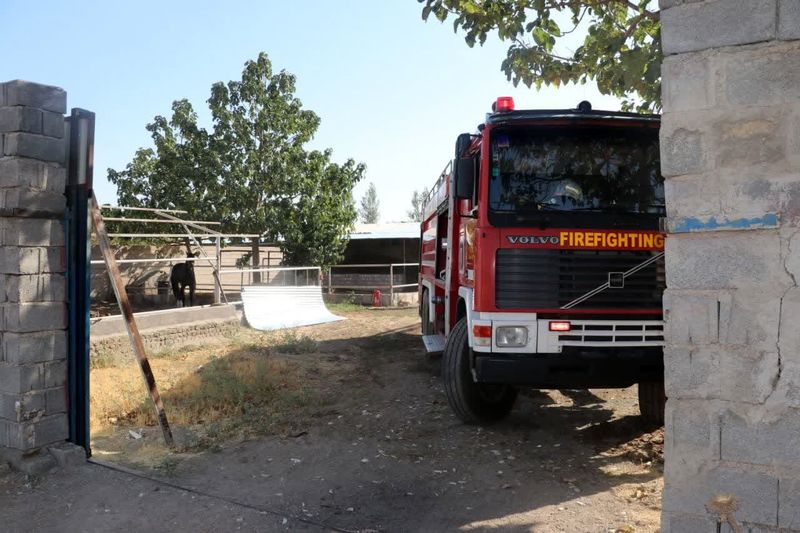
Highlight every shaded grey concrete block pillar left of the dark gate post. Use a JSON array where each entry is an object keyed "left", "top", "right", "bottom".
[{"left": 0, "top": 80, "right": 68, "bottom": 462}]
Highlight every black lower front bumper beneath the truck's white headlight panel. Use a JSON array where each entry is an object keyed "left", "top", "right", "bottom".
[{"left": 473, "top": 347, "right": 664, "bottom": 389}]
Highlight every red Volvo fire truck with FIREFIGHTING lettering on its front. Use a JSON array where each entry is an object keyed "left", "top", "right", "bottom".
[{"left": 419, "top": 97, "right": 665, "bottom": 423}]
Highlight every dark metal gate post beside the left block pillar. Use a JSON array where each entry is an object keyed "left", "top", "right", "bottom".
[{"left": 64, "top": 109, "right": 95, "bottom": 456}]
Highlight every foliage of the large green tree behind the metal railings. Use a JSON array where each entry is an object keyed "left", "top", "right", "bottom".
[{"left": 108, "top": 53, "right": 365, "bottom": 265}]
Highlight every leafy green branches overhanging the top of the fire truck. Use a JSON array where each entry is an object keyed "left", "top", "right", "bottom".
[{"left": 418, "top": 0, "right": 662, "bottom": 111}]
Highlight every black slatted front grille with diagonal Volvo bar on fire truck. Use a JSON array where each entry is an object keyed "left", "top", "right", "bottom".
[{"left": 495, "top": 248, "right": 666, "bottom": 309}]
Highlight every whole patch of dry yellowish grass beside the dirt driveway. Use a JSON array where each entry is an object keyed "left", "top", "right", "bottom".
[{"left": 90, "top": 308, "right": 417, "bottom": 473}]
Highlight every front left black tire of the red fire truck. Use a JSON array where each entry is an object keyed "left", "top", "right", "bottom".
[{"left": 442, "top": 318, "right": 517, "bottom": 424}]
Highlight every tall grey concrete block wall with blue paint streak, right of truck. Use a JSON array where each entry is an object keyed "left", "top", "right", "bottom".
[{"left": 661, "top": 0, "right": 800, "bottom": 533}]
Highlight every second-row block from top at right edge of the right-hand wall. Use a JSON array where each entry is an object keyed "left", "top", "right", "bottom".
[{"left": 725, "top": 43, "right": 800, "bottom": 106}]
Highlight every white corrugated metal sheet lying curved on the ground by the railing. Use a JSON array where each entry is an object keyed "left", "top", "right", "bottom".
[{"left": 242, "top": 285, "right": 344, "bottom": 331}]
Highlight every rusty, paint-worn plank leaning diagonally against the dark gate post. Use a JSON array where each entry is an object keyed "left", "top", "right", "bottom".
[{"left": 92, "top": 195, "right": 175, "bottom": 448}]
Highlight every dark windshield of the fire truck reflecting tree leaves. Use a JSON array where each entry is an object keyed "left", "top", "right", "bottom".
[{"left": 489, "top": 127, "right": 665, "bottom": 227}]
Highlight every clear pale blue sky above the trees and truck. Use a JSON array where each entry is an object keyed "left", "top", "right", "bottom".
[{"left": 0, "top": 0, "right": 619, "bottom": 221}]
